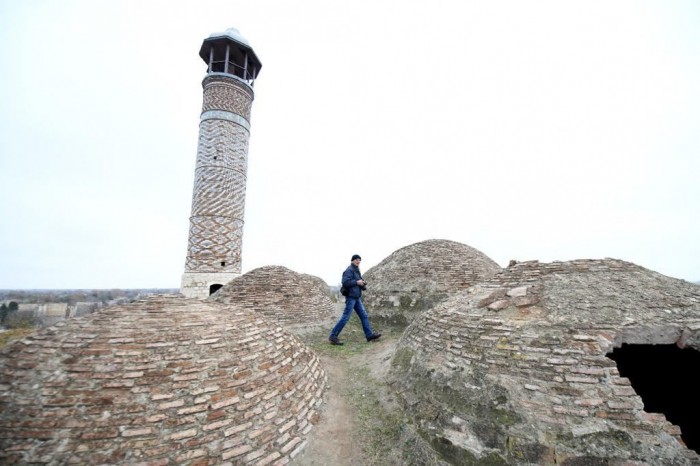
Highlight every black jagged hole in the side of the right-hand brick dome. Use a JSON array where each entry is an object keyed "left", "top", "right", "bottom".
[{"left": 607, "top": 343, "right": 700, "bottom": 453}]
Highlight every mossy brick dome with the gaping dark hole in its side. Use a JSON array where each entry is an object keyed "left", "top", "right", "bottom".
[{"left": 388, "top": 259, "right": 700, "bottom": 465}]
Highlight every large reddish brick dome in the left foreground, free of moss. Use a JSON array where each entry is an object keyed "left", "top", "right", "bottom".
[{"left": 0, "top": 296, "right": 327, "bottom": 465}]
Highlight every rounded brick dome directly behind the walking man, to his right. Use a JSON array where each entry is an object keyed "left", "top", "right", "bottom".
[{"left": 363, "top": 239, "right": 501, "bottom": 325}]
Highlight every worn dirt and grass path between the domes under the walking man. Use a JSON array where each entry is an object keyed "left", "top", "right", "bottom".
[{"left": 290, "top": 303, "right": 447, "bottom": 466}]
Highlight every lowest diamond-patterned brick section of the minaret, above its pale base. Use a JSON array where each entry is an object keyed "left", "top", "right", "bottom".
[{"left": 185, "top": 217, "right": 243, "bottom": 273}]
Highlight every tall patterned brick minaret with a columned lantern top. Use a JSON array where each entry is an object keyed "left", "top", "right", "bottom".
[{"left": 180, "top": 28, "right": 262, "bottom": 298}]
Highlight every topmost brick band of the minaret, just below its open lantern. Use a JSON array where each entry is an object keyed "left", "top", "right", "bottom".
[{"left": 202, "top": 76, "right": 253, "bottom": 121}]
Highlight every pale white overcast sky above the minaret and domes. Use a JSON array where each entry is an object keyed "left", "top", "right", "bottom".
[{"left": 0, "top": 0, "right": 700, "bottom": 289}]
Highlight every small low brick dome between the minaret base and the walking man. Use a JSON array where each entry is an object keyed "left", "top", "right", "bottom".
[{"left": 208, "top": 265, "right": 335, "bottom": 329}]
